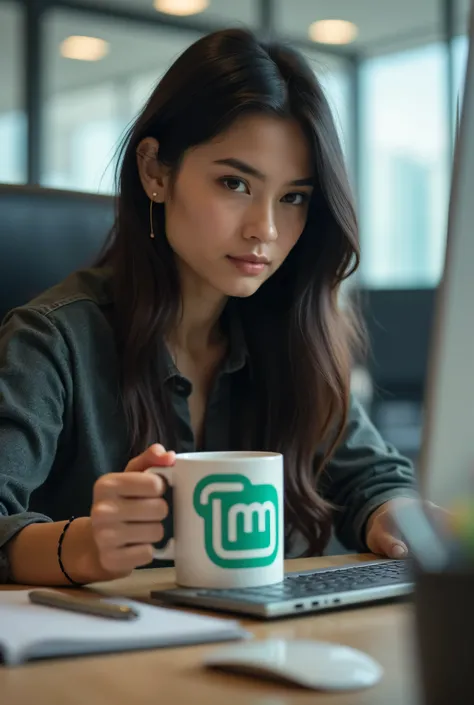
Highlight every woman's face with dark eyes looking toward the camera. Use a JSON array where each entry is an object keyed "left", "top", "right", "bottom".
[{"left": 142, "top": 115, "right": 314, "bottom": 297}]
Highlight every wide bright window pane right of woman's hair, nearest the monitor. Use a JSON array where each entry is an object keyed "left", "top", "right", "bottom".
[{"left": 361, "top": 44, "right": 451, "bottom": 287}]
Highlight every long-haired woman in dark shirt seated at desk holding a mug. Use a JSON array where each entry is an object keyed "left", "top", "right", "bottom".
[{"left": 0, "top": 30, "right": 422, "bottom": 585}]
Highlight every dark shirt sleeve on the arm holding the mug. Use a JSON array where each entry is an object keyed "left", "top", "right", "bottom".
[{"left": 0, "top": 309, "right": 68, "bottom": 582}]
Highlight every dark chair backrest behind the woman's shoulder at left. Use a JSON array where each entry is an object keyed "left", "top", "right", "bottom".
[{"left": 0, "top": 184, "right": 114, "bottom": 320}]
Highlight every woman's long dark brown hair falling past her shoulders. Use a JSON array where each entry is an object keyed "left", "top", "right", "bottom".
[{"left": 101, "top": 29, "right": 359, "bottom": 554}]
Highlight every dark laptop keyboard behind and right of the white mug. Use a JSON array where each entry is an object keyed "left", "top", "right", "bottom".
[{"left": 193, "top": 560, "right": 412, "bottom": 603}]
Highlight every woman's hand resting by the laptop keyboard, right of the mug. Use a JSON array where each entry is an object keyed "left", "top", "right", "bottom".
[{"left": 365, "top": 497, "right": 449, "bottom": 558}]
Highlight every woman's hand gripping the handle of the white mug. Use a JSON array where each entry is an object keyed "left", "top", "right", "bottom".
[{"left": 91, "top": 444, "right": 175, "bottom": 578}]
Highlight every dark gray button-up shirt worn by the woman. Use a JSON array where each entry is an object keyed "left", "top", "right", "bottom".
[{"left": 0, "top": 269, "right": 416, "bottom": 582}]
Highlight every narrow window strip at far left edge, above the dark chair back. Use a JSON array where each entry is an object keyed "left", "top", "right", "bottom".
[{"left": 0, "top": 2, "right": 26, "bottom": 183}]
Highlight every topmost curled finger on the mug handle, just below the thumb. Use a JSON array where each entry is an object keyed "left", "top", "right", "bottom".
[{"left": 93, "top": 472, "right": 166, "bottom": 504}]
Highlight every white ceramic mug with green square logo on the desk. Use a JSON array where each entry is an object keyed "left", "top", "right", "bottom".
[{"left": 147, "top": 451, "right": 284, "bottom": 588}]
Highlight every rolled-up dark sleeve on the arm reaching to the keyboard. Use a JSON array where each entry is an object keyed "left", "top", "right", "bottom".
[{"left": 321, "top": 397, "right": 418, "bottom": 551}]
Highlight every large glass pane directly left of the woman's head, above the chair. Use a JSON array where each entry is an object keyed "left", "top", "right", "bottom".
[{"left": 41, "top": 11, "right": 202, "bottom": 193}]
